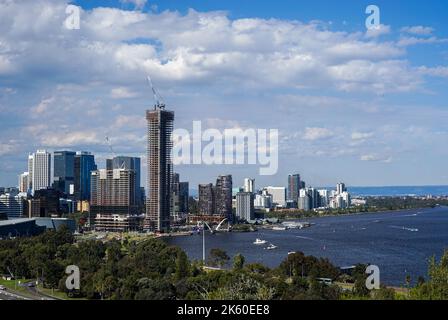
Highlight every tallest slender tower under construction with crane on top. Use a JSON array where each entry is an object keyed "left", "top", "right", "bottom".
[{"left": 144, "top": 103, "right": 174, "bottom": 232}]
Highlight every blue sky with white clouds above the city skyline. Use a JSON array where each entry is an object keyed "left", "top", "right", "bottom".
[{"left": 0, "top": 0, "right": 448, "bottom": 188}]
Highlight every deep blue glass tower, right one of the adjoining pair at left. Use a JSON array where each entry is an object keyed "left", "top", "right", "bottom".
[{"left": 74, "top": 152, "right": 97, "bottom": 201}]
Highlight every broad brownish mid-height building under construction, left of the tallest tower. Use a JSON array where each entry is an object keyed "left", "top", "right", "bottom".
[{"left": 90, "top": 169, "right": 139, "bottom": 232}]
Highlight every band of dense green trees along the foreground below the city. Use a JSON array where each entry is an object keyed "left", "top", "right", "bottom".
[{"left": 0, "top": 228, "right": 448, "bottom": 300}]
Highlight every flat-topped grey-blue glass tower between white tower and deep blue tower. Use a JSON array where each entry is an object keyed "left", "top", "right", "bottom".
[{"left": 53, "top": 151, "right": 76, "bottom": 195}]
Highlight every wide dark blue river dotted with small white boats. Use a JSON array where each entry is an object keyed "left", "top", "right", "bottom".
[{"left": 167, "top": 207, "right": 448, "bottom": 286}]
